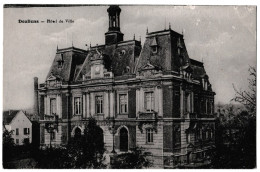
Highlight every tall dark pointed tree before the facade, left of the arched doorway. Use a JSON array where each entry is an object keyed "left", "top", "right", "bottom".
[{"left": 64, "top": 118, "right": 106, "bottom": 168}]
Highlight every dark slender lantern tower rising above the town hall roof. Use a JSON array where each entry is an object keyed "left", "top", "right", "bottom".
[{"left": 105, "top": 5, "right": 124, "bottom": 45}]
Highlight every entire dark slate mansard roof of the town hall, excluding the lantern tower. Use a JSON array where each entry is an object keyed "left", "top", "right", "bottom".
[{"left": 47, "top": 30, "right": 209, "bottom": 81}]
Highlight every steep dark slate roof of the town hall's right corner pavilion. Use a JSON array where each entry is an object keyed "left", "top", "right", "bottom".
[{"left": 136, "top": 29, "right": 206, "bottom": 79}]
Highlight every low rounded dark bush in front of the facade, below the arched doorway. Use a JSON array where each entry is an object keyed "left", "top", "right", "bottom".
[{"left": 111, "top": 147, "right": 153, "bottom": 169}]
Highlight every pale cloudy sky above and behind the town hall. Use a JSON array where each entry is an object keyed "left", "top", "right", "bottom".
[{"left": 3, "top": 5, "right": 256, "bottom": 110}]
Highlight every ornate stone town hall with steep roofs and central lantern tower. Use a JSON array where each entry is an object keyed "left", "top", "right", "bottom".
[{"left": 34, "top": 5, "right": 215, "bottom": 168}]
